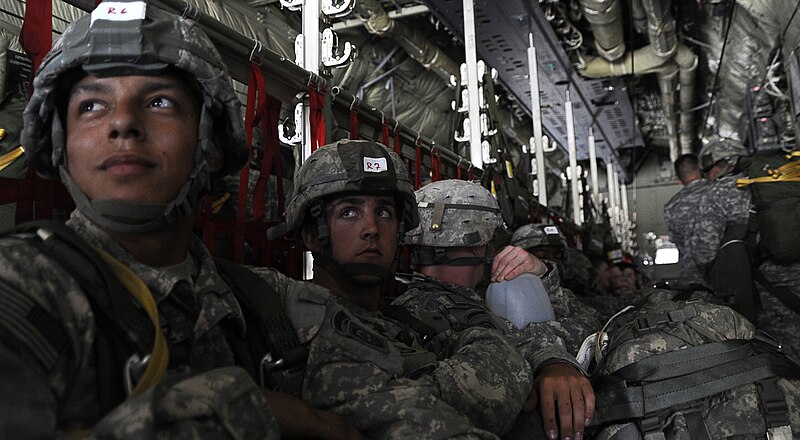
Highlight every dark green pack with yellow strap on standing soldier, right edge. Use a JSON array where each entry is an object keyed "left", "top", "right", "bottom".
[{"left": 736, "top": 150, "right": 800, "bottom": 264}]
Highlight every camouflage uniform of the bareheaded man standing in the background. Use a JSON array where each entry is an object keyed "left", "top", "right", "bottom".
[{"left": 664, "top": 179, "right": 709, "bottom": 277}]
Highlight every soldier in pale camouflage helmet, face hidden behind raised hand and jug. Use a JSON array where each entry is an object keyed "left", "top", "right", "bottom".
[{"left": 393, "top": 180, "right": 594, "bottom": 438}]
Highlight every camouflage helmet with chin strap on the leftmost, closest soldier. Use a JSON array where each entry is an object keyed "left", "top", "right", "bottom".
[{"left": 21, "top": 0, "right": 248, "bottom": 233}]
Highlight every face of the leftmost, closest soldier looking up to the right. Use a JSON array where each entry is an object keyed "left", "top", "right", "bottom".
[{"left": 66, "top": 75, "right": 200, "bottom": 204}]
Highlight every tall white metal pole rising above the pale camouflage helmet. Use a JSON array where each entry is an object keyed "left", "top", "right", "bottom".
[{"left": 463, "top": 0, "right": 482, "bottom": 168}]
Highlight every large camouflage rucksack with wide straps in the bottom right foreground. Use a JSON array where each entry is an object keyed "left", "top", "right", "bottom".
[{"left": 587, "top": 301, "right": 800, "bottom": 440}]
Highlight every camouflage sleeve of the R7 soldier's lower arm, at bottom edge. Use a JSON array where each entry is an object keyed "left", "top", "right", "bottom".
[{"left": 303, "top": 328, "right": 497, "bottom": 440}]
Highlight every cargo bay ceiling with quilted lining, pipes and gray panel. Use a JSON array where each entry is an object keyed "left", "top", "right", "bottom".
[{"left": 6, "top": 0, "right": 800, "bottom": 188}]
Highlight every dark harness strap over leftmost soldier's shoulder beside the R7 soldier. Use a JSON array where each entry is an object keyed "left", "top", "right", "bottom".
[{"left": 214, "top": 258, "right": 308, "bottom": 395}]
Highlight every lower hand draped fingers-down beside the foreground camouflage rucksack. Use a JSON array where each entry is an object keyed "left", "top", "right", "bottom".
[{"left": 523, "top": 363, "right": 594, "bottom": 440}]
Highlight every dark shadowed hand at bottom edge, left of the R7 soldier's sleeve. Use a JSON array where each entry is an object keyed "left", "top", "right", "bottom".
[{"left": 264, "top": 390, "right": 366, "bottom": 440}]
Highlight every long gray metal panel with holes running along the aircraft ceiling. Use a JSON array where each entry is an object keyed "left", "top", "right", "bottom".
[{"left": 424, "top": 0, "right": 644, "bottom": 179}]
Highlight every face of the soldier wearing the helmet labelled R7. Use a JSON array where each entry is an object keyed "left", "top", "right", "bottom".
[{"left": 325, "top": 195, "right": 399, "bottom": 269}]
